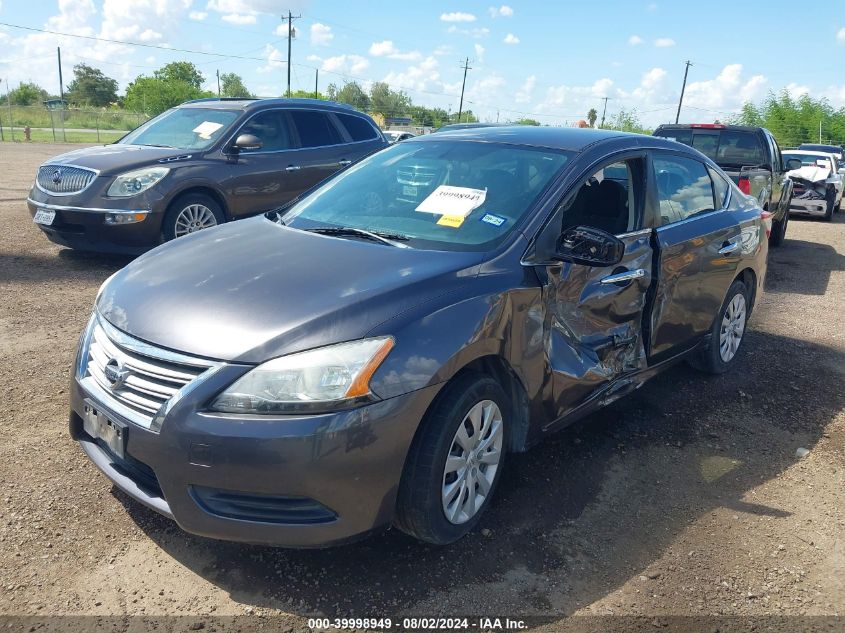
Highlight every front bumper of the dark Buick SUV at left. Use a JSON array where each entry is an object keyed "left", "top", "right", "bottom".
[{"left": 26, "top": 190, "right": 164, "bottom": 255}]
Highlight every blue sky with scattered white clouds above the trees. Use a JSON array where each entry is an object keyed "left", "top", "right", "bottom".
[{"left": 0, "top": 0, "right": 845, "bottom": 125}]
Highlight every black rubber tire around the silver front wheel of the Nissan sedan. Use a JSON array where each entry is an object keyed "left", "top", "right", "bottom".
[{"left": 394, "top": 372, "right": 512, "bottom": 545}]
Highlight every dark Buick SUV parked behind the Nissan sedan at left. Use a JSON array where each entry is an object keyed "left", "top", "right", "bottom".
[{"left": 27, "top": 99, "right": 387, "bottom": 254}]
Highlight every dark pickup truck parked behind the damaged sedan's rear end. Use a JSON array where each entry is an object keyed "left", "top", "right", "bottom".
[{"left": 654, "top": 123, "right": 801, "bottom": 246}]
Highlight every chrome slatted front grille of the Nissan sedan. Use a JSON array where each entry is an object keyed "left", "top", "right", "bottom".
[{"left": 82, "top": 320, "right": 216, "bottom": 428}]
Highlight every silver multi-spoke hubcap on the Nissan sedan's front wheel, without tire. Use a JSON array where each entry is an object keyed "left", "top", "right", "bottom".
[{"left": 441, "top": 400, "right": 504, "bottom": 525}]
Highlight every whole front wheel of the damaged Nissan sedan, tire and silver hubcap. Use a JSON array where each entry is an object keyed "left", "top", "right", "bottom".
[{"left": 395, "top": 373, "right": 511, "bottom": 545}]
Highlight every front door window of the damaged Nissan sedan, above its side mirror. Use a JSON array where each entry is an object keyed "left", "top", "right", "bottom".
[{"left": 561, "top": 158, "right": 643, "bottom": 235}]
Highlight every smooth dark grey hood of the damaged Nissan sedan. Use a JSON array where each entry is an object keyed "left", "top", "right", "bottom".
[{"left": 97, "top": 216, "right": 482, "bottom": 363}]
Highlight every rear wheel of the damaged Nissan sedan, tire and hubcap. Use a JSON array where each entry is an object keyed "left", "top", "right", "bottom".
[{"left": 690, "top": 280, "right": 749, "bottom": 374}]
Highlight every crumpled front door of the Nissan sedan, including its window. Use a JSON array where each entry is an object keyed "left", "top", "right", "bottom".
[{"left": 538, "top": 156, "right": 653, "bottom": 426}]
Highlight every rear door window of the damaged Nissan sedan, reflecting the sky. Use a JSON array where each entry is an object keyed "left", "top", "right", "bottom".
[{"left": 654, "top": 156, "right": 714, "bottom": 225}]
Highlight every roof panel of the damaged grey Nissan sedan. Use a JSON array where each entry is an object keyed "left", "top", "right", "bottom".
[{"left": 408, "top": 125, "right": 640, "bottom": 152}]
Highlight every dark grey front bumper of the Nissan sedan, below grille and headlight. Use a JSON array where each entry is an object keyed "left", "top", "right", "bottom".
[{"left": 70, "top": 368, "right": 440, "bottom": 547}]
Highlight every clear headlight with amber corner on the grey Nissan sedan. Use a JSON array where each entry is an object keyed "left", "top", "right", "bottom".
[{"left": 211, "top": 336, "right": 393, "bottom": 414}]
